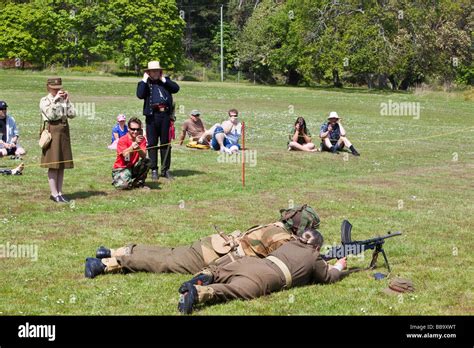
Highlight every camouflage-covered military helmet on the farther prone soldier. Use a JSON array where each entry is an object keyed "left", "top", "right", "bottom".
[{"left": 280, "top": 204, "right": 321, "bottom": 236}]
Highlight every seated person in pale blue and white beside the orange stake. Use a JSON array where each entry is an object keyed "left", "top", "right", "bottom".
[{"left": 211, "top": 109, "right": 242, "bottom": 154}]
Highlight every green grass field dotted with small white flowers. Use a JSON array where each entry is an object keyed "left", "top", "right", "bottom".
[{"left": 0, "top": 71, "right": 474, "bottom": 315}]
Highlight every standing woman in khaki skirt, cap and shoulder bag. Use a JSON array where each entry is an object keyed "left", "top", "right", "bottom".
[{"left": 40, "top": 77, "right": 75, "bottom": 203}]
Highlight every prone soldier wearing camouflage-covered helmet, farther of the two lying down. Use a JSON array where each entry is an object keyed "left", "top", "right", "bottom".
[{"left": 85, "top": 205, "right": 320, "bottom": 278}]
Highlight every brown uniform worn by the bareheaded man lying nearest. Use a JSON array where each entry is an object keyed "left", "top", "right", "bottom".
[{"left": 196, "top": 240, "right": 341, "bottom": 303}]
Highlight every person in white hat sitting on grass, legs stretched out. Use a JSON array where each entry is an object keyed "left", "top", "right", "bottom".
[{"left": 319, "top": 111, "right": 360, "bottom": 156}]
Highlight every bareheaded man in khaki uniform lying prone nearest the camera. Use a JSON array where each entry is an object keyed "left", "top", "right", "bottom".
[{"left": 178, "top": 229, "right": 346, "bottom": 314}]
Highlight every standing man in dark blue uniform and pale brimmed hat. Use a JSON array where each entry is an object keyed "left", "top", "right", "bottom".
[{"left": 137, "top": 61, "right": 179, "bottom": 181}]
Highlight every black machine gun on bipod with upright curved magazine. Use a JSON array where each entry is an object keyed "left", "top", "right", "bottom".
[{"left": 321, "top": 220, "right": 402, "bottom": 272}]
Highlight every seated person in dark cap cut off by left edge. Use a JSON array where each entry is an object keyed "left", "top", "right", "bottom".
[{"left": 0, "top": 101, "right": 25, "bottom": 158}]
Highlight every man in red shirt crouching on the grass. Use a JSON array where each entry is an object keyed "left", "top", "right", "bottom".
[{"left": 112, "top": 117, "right": 150, "bottom": 190}]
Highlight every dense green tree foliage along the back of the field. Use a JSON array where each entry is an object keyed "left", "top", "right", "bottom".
[{"left": 0, "top": 0, "right": 474, "bottom": 89}]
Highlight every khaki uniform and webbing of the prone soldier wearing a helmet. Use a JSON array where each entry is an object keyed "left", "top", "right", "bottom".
[{"left": 102, "top": 222, "right": 294, "bottom": 274}]
